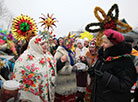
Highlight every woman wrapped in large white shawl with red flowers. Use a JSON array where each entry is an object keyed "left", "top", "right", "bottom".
[{"left": 14, "top": 35, "right": 56, "bottom": 102}]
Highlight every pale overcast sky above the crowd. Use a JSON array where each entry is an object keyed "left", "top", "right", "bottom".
[{"left": 4, "top": 0, "right": 138, "bottom": 37}]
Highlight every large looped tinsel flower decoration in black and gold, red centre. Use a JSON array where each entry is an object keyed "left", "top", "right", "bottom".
[{"left": 85, "top": 4, "right": 132, "bottom": 46}]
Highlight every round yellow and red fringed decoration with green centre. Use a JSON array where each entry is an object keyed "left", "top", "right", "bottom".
[{"left": 11, "top": 14, "right": 37, "bottom": 40}]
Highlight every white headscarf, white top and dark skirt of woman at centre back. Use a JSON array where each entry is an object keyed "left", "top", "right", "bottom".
[{"left": 75, "top": 39, "right": 88, "bottom": 102}]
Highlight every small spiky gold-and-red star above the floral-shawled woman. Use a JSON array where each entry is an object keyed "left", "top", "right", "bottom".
[{"left": 39, "top": 14, "right": 57, "bottom": 30}]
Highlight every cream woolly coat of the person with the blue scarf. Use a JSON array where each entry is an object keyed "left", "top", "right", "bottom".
[{"left": 54, "top": 46, "right": 77, "bottom": 95}]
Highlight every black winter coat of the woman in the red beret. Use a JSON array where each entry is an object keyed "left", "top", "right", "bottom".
[{"left": 92, "top": 43, "right": 137, "bottom": 102}]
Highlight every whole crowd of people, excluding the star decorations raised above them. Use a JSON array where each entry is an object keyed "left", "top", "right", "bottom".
[{"left": 0, "top": 29, "right": 138, "bottom": 102}]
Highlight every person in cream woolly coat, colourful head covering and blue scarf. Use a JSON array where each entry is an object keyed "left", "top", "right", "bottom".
[{"left": 54, "top": 38, "right": 77, "bottom": 102}]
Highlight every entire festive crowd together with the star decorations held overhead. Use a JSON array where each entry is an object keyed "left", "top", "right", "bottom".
[{"left": 0, "top": 4, "right": 138, "bottom": 102}]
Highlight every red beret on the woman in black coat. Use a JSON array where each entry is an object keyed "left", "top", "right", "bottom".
[{"left": 104, "top": 29, "right": 124, "bottom": 44}]
